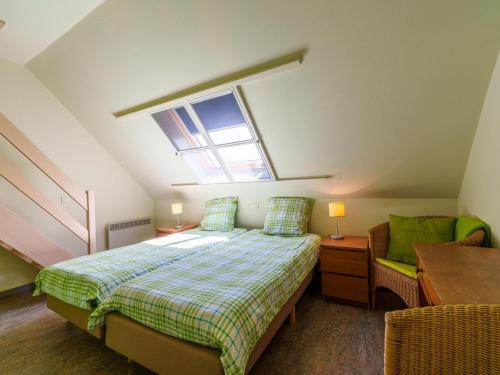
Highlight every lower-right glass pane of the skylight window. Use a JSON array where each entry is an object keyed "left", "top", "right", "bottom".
[{"left": 217, "top": 143, "right": 271, "bottom": 181}]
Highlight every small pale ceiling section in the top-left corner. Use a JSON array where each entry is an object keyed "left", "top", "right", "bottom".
[{"left": 0, "top": 0, "right": 104, "bottom": 64}]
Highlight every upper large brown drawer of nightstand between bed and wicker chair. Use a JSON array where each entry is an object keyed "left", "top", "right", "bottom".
[{"left": 320, "top": 249, "right": 368, "bottom": 277}]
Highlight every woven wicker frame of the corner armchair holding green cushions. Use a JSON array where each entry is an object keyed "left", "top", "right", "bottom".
[{"left": 368, "top": 216, "right": 485, "bottom": 308}]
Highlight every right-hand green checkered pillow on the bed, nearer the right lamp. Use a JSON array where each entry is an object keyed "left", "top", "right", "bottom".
[{"left": 263, "top": 197, "right": 314, "bottom": 236}]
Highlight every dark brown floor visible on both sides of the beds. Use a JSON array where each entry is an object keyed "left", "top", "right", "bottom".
[{"left": 0, "top": 285, "right": 402, "bottom": 375}]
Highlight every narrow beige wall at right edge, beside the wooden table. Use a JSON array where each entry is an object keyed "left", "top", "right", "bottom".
[{"left": 459, "top": 54, "right": 500, "bottom": 247}]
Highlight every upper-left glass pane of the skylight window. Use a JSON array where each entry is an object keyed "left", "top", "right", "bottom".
[{"left": 152, "top": 107, "right": 207, "bottom": 150}]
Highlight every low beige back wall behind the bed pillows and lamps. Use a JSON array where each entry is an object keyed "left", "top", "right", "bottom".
[{"left": 155, "top": 181, "right": 457, "bottom": 235}]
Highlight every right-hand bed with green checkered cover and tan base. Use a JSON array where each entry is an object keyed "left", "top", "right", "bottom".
[{"left": 88, "top": 230, "right": 320, "bottom": 375}]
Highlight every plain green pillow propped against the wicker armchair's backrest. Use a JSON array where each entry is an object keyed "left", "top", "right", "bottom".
[{"left": 386, "top": 215, "right": 455, "bottom": 265}]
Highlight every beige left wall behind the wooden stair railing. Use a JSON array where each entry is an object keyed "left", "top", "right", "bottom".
[{"left": 0, "top": 60, "right": 153, "bottom": 291}]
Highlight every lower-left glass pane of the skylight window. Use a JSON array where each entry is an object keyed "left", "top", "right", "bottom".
[{"left": 183, "top": 150, "right": 229, "bottom": 184}]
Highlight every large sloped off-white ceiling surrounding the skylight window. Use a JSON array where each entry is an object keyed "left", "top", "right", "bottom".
[{"left": 28, "top": 0, "right": 500, "bottom": 198}]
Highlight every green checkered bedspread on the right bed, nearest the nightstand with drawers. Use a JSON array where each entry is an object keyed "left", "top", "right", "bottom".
[{"left": 88, "top": 230, "right": 320, "bottom": 374}]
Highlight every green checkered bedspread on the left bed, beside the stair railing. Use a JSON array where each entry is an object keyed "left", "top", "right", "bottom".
[{"left": 34, "top": 228, "right": 246, "bottom": 310}]
